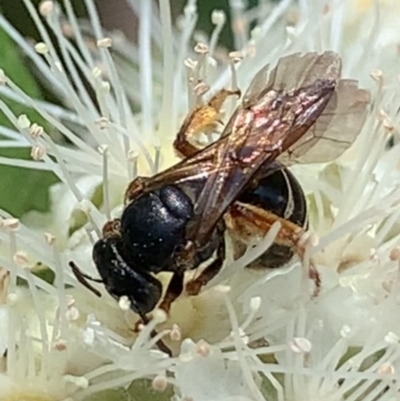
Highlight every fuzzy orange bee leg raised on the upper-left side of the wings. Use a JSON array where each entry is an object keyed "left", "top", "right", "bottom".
[{"left": 174, "top": 89, "right": 241, "bottom": 158}]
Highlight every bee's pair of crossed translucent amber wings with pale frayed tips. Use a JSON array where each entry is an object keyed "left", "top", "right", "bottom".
[{"left": 145, "top": 52, "right": 368, "bottom": 244}]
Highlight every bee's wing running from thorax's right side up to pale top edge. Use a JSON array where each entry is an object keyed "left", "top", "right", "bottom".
[{"left": 189, "top": 52, "right": 341, "bottom": 242}]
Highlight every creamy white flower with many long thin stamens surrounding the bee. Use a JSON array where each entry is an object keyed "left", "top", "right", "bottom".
[{"left": 0, "top": 0, "right": 400, "bottom": 401}]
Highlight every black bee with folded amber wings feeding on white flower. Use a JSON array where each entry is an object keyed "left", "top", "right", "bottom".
[{"left": 71, "top": 51, "right": 369, "bottom": 354}]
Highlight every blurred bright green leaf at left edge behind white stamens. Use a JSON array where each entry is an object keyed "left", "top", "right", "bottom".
[{"left": 0, "top": 25, "right": 57, "bottom": 217}]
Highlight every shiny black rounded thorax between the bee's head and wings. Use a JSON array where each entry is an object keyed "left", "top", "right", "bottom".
[{"left": 121, "top": 182, "right": 223, "bottom": 273}]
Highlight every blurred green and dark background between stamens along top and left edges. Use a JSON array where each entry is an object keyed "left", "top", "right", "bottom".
[{"left": 0, "top": 0, "right": 268, "bottom": 217}]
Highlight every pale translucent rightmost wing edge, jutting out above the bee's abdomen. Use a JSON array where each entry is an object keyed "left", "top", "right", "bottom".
[{"left": 279, "top": 79, "right": 370, "bottom": 165}]
